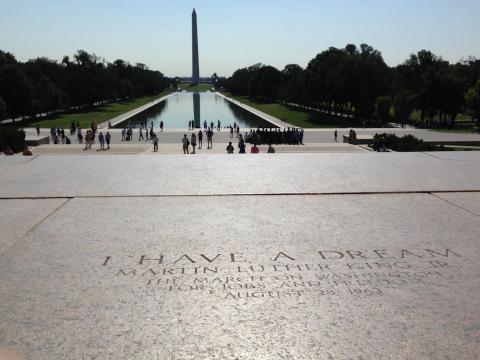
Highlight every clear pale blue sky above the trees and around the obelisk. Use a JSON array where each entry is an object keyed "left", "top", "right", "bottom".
[{"left": 0, "top": 0, "right": 480, "bottom": 76}]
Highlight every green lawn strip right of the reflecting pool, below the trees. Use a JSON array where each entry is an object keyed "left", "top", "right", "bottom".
[{"left": 224, "top": 92, "right": 350, "bottom": 129}]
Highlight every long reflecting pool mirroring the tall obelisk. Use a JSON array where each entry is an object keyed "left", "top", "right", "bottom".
[{"left": 116, "top": 92, "right": 275, "bottom": 129}]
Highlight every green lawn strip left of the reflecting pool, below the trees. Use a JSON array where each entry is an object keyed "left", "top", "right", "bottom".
[{"left": 24, "top": 91, "right": 170, "bottom": 129}]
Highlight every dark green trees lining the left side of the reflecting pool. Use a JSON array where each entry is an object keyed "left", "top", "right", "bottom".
[{"left": 0, "top": 50, "right": 169, "bottom": 119}]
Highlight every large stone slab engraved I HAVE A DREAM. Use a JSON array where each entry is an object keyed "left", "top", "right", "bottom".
[{"left": 0, "top": 195, "right": 480, "bottom": 360}]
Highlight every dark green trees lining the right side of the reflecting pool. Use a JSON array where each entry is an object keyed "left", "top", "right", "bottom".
[{"left": 222, "top": 44, "right": 480, "bottom": 127}]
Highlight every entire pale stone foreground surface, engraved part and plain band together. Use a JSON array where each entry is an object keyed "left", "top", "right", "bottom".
[{"left": 0, "top": 152, "right": 480, "bottom": 359}]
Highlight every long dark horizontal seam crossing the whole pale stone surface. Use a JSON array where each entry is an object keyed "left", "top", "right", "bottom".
[{"left": 0, "top": 189, "right": 480, "bottom": 200}]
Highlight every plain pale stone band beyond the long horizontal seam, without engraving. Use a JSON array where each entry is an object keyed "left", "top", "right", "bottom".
[{"left": 0, "top": 152, "right": 480, "bottom": 198}]
